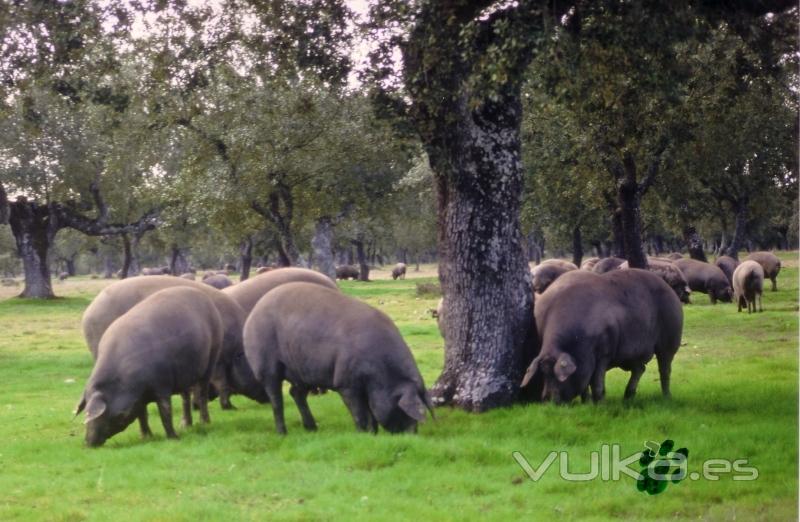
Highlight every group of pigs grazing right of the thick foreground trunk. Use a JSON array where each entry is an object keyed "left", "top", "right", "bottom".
[{"left": 512, "top": 252, "right": 781, "bottom": 402}]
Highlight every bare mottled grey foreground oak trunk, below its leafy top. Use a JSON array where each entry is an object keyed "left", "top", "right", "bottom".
[{"left": 427, "top": 96, "right": 533, "bottom": 411}]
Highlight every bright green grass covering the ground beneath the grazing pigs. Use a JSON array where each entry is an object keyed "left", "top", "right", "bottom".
[{"left": 0, "top": 253, "right": 798, "bottom": 521}]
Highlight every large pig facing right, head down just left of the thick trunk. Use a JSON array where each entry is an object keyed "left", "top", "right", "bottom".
[{"left": 244, "top": 283, "right": 433, "bottom": 434}]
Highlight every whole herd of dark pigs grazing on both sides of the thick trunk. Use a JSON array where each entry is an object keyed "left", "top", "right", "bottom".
[{"left": 70, "top": 252, "right": 780, "bottom": 446}]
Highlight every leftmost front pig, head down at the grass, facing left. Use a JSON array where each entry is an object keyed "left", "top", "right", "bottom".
[{"left": 76, "top": 287, "right": 224, "bottom": 446}]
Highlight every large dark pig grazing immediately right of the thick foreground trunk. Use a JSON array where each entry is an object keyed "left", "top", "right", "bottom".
[{"left": 522, "top": 269, "right": 683, "bottom": 403}]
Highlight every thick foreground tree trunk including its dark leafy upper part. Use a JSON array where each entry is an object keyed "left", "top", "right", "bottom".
[{"left": 403, "top": 0, "right": 542, "bottom": 411}]
